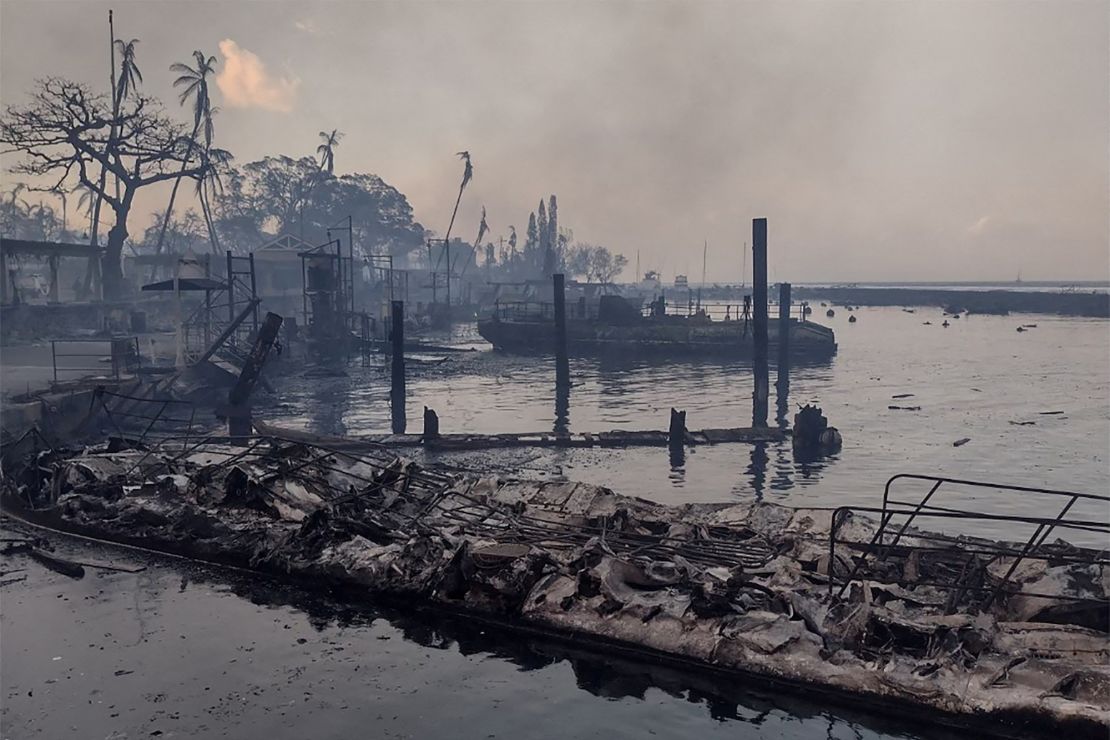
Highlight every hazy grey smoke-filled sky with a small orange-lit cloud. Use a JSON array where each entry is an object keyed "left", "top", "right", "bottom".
[{"left": 0, "top": 0, "right": 1110, "bottom": 282}]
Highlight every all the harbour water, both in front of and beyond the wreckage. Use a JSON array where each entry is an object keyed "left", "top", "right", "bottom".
[{"left": 0, "top": 308, "right": 1110, "bottom": 740}]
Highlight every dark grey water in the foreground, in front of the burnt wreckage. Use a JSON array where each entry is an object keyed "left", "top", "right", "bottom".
[{"left": 0, "top": 525, "right": 958, "bottom": 740}]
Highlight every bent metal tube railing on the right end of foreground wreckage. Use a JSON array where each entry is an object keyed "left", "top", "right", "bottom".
[{"left": 828, "top": 474, "right": 1110, "bottom": 614}]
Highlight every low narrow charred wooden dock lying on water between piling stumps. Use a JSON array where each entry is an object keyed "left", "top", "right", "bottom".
[{"left": 254, "top": 419, "right": 789, "bottom": 452}]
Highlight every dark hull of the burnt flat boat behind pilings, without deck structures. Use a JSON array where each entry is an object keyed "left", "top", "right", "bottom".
[{"left": 478, "top": 316, "right": 837, "bottom": 359}]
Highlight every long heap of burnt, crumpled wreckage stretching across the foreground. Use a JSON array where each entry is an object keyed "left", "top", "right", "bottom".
[{"left": 3, "top": 437, "right": 1110, "bottom": 737}]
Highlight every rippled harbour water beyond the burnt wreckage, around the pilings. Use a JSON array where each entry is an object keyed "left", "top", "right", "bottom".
[{"left": 275, "top": 305, "right": 1110, "bottom": 540}]
